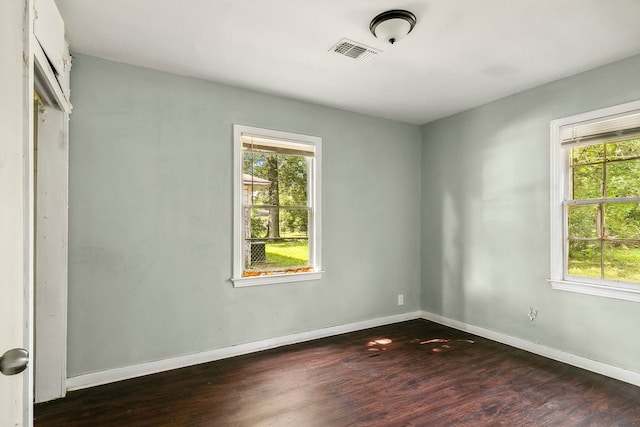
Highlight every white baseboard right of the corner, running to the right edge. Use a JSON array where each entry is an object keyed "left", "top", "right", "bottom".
[{"left": 420, "top": 311, "right": 640, "bottom": 386}]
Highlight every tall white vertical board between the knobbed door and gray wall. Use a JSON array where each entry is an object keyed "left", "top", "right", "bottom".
[{"left": 33, "top": 102, "right": 68, "bottom": 402}]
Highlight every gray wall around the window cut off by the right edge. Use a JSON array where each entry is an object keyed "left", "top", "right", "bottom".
[{"left": 421, "top": 56, "right": 640, "bottom": 372}]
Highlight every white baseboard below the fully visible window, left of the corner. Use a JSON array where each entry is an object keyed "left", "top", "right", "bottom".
[{"left": 67, "top": 311, "right": 422, "bottom": 390}]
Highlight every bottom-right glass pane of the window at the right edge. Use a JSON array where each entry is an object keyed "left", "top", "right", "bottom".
[{"left": 604, "top": 242, "right": 640, "bottom": 282}]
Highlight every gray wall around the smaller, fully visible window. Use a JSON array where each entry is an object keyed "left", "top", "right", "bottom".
[{"left": 68, "top": 55, "right": 421, "bottom": 377}]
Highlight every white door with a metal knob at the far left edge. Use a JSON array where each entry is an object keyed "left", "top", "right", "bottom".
[{"left": 0, "top": 1, "right": 32, "bottom": 426}]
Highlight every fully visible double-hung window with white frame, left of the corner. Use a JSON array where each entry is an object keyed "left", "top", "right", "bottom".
[{"left": 232, "top": 125, "right": 322, "bottom": 286}]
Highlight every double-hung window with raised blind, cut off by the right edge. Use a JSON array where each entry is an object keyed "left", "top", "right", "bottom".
[{"left": 551, "top": 102, "right": 640, "bottom": 301}]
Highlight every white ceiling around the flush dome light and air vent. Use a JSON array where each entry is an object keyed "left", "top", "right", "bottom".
[{"left": 56, "top": 0, "right": 640, "bottom": 124}]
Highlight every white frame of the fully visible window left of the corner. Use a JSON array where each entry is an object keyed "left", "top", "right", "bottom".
[{"left": 231, "top": 124, "right": 323, "bottom": 287}]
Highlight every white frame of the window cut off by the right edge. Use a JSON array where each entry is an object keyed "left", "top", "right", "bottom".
[{"left": 549, "top": 101, "right": 640, "bottom": 302}]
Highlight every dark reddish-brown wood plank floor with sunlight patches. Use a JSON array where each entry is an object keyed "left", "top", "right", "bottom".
[{"left": 35, "top": 320, "right": 640, "bottom": 427}]
